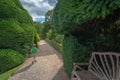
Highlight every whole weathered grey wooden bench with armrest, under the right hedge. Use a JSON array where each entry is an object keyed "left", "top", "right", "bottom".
[{"left": 71, "top": 52, "right": 120, "bottom": 80}]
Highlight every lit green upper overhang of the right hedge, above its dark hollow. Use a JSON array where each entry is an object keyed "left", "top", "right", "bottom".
[{"left": 53, "top": 0, "right": 120, "bottom": 34}]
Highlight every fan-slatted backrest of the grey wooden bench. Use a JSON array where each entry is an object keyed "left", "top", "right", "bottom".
[{"left": 88, "top": 52, "right": 120, "bottom": 80}]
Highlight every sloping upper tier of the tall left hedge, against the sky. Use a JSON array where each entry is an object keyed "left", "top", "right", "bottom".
[{"left": 0, "top": 0, "right": 33, "bottom": 25}]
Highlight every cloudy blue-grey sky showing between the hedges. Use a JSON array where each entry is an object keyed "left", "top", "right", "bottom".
[{"left": 20, "top": 0, "right": 57, "bottom": 22}]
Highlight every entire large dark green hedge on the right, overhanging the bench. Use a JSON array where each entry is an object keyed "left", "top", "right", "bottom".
[{"left": 49, "top": 0, "right": 120, "bottom": 76}]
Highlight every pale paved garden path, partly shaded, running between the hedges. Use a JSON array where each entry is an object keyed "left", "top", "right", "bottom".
[{"left": 8, "top": 40, "right": 69, "bottom": 80}]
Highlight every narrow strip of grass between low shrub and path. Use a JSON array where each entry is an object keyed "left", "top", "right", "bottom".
[{"left": 0, "top": 64, "right": 22, "bottom": 80}]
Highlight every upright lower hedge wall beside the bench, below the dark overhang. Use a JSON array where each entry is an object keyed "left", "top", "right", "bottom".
[{"left": 63, "top": 36, "right": 91, "bottom": 77}]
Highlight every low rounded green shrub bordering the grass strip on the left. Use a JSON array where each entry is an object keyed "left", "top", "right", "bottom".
[{"left": 0, "top": 49, "right": 24, "bottom": 73}]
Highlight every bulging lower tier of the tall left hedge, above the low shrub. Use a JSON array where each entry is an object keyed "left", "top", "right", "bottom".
[{"left": 0, "top": 20, "right": 34, "bottom": 54}]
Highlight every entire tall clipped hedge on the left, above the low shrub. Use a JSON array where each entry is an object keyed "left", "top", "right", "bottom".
[{"left": 0, "top": 0, "right": 36, "bottom": 54}]
